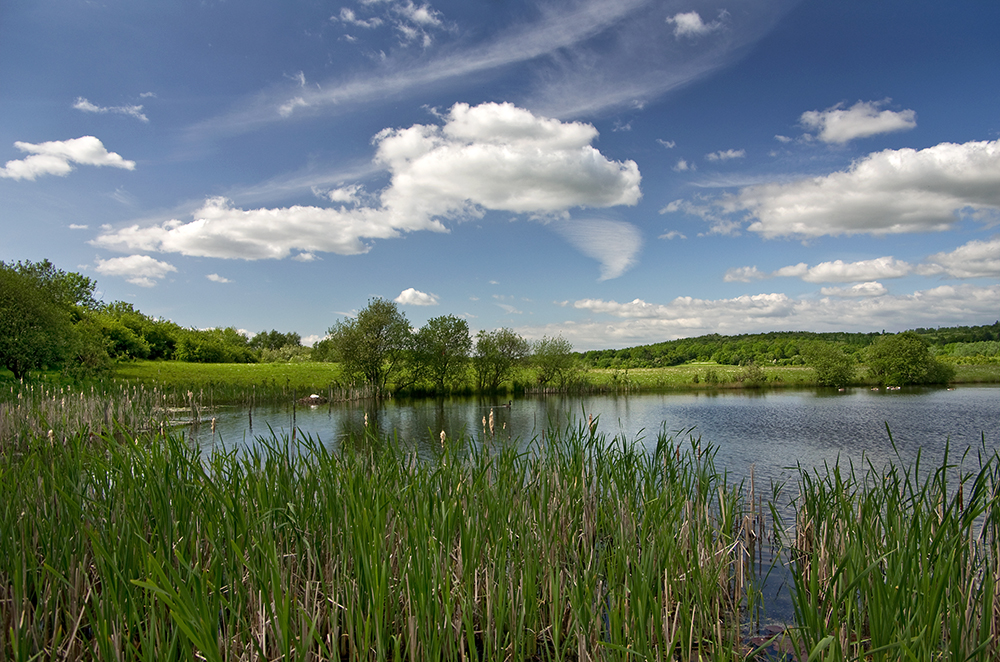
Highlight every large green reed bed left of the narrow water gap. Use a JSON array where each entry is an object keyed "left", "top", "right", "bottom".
[{"left": 0, "top": 418, "right": 761, "bottom": 660}]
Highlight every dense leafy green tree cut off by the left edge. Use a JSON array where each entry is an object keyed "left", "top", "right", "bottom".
[{"left": 0, "top": 262, "right": 73, "bottom": 379}]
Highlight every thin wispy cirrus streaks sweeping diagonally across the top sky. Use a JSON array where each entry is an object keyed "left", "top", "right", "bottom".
[{"left": 189, "top": 0, "right": 794, "bottom": 141}]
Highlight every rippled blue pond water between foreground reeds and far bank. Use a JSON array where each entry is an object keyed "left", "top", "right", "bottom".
[{"left": 187, "top": 386, "right": 1000, "bottom": 485}]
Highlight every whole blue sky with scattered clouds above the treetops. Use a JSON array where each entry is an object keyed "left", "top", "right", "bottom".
[{"left": 0, "top": 0, "right": 1000, "bottom": 350}]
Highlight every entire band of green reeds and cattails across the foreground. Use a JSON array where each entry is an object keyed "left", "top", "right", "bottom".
[{"left": 0, "top": 400, "right": 1000, "bottom": 662}]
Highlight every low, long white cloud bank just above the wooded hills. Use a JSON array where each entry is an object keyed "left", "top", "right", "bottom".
[{"left": 548, "top": 284, "right": 1000, "bottom": 349}]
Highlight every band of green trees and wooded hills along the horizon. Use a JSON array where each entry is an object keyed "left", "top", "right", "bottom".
[{"left": 0, "top": 260, "right": 1000, "bottom": 393}]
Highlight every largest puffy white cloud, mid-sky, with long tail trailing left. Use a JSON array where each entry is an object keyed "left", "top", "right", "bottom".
[{"left": 94, "top": 103, "right": 641, "bottom": 273}]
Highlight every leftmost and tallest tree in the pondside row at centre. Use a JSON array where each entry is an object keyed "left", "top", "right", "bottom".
[{"left": 328, "top": 298, "right": 411, "bottom": 395}]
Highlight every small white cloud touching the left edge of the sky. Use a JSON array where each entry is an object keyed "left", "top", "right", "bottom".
[{"left": 0, "top": 136, "right": 135, "bottom": 180}]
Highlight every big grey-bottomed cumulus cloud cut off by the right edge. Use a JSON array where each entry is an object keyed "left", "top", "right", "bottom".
[{"left": 663, "top": 140, "right": 1000, "bottom": 238}]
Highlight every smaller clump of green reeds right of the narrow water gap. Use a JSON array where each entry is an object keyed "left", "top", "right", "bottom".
[{"left": 790, "top": 440, "right": 1000, "bottom": 661}]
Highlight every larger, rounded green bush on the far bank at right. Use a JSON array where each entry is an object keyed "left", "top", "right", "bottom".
[{"left": 866, "top": 331, "right": 954, "bottom": 386}]
